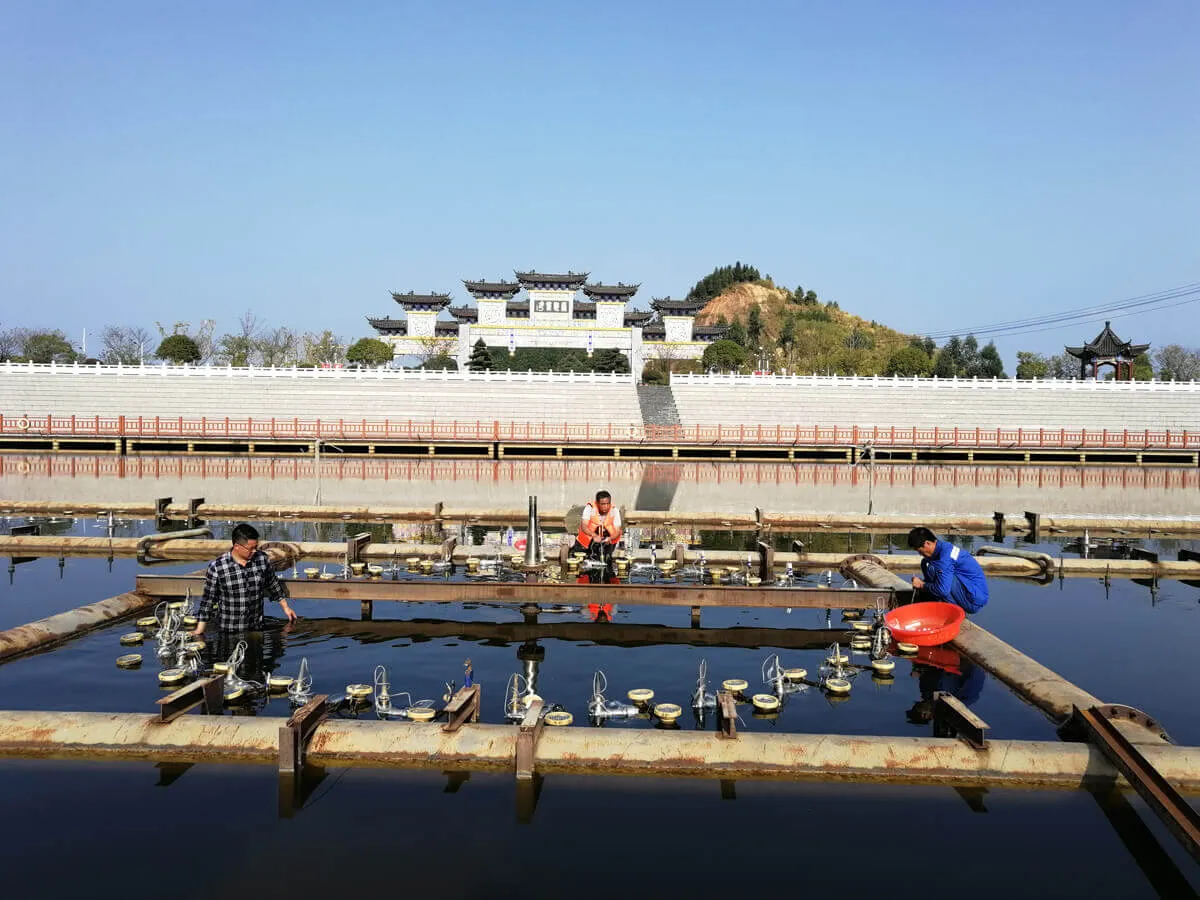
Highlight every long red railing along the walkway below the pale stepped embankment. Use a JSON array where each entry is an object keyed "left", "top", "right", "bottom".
[{"left": 0, "top": 415, "right": 1200, "bottom": 450}]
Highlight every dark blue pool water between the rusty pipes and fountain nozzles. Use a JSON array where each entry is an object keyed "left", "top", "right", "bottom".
[{"left": 0, "top": 513, "right": 1200, "bottom": 898}]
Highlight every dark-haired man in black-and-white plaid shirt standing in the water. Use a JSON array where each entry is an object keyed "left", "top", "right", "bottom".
[{"left": 192, "top": 523, "right": 296, "bottom": 637}]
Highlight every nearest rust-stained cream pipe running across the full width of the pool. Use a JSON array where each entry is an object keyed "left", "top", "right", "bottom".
[{"left": 0, "top": 712, "right": 1200, "bottom": 792}]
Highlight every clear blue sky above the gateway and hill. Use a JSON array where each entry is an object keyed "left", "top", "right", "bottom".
[{"left": 0, "top": 0, "right": 1200, "bottom": 372}]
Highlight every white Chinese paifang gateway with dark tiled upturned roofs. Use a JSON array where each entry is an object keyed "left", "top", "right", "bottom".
[{"left": 367, "top": 272, "right": 725, "bottom": 376}]
